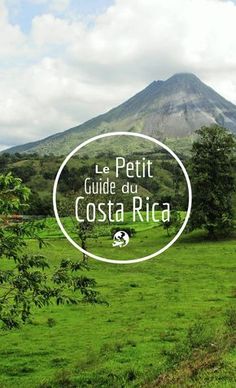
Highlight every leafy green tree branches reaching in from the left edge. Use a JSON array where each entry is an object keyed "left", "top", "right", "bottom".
[{"left": 0, "top": 174, "right": 99, "bottom": 328}]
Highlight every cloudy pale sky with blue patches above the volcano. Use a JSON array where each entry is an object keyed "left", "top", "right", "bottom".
[{"left": 0, "top": 0, "right": 236, "bottom": 150}]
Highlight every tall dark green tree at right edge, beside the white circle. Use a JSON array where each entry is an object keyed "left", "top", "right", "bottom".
[{"left": 190, "top": 125, "right": 235, "bottom": 239}]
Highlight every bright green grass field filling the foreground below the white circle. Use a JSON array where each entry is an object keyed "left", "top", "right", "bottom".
[{"left": 0, "top": 220, "right": 236, "bottom": 388}]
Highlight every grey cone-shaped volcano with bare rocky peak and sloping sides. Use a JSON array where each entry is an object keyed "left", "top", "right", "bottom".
[{"left": 7, "top": 73, "right": 236, "bottom": 154}]
